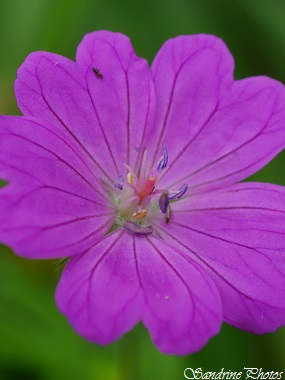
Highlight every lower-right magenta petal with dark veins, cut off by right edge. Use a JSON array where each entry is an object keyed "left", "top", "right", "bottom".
[{"left": 161, "top": 183, "right": 285, "bottom": 333}]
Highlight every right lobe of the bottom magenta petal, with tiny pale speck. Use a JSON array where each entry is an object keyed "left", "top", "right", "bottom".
[{"left": 135, "top": 238, "right": 222, "bottom": 355}]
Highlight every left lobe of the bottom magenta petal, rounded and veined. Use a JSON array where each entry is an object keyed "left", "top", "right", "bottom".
[{"left": 56, "top": 231, "right": 144, "bottom": 344}]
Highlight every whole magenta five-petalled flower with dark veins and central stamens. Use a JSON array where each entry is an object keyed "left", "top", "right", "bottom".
[{"left": 0, "top": 32, "right": 285, "bottom": 354}]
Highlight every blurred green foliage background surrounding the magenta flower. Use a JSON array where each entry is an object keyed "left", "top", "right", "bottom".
[{"left": 0, "top": 0, "right": 285, "bottom": 380}]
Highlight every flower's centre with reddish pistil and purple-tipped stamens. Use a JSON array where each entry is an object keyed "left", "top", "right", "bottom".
[{"left": 111, "top": 146, "right": 188, "bottom": 235}]
